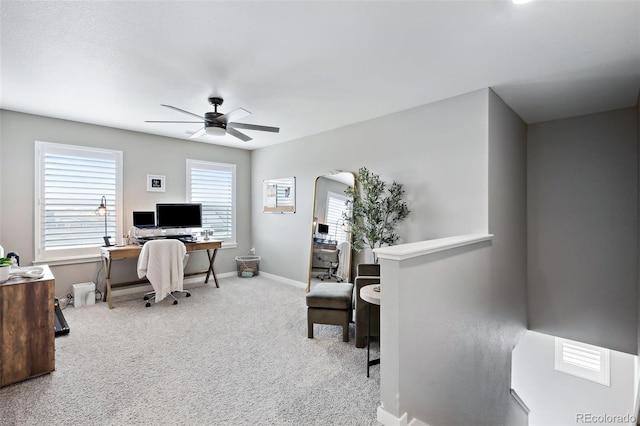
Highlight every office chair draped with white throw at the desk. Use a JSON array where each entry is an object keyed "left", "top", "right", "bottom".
[{"left": 137, "top": 239, "right": 191, "bottom": 307}]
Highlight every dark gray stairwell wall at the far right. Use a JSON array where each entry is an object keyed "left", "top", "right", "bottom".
[{"left": 527, "top": 108, "right": 638, "bottom": 354}]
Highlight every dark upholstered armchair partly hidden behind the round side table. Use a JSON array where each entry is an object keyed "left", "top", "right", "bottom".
[{"left": 353, "top": 263, "right": 380, "bottom": 348}]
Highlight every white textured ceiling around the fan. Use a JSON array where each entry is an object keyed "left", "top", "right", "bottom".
[{"left": 0, "top": 0, "right": 640, "bottom": 149}]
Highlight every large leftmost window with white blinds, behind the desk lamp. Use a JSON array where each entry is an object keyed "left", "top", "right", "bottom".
[{"left": 34, "top": 141, "right": 122, "bottom": 262}]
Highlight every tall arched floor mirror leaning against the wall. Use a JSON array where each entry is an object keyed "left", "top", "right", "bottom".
[{"left": 307, "top": 172, "right": 356, "bottom": 291}]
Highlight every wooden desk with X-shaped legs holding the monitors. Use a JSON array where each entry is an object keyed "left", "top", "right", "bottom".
[{"left": 100, "top": 241, "right": 222, "bottom": 309}]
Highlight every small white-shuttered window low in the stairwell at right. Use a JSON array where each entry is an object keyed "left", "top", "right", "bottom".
[{"left": 555, "top": 337, "right": 610, "bottom": 386}]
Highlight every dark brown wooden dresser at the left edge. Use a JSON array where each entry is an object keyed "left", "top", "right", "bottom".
[{"left": 0, "top": 265, "right": 55, "bottom": 387}]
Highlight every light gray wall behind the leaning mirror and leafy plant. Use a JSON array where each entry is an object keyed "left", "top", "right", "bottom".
[{"left": 251, "top": 89, "right": 488, "bottom": 283}]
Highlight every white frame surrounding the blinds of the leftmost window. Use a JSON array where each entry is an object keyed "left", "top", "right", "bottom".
[{"left": 34, "top": 141, "right": 123, "bottom": 264}]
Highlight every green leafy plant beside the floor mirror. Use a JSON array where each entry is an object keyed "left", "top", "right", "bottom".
[{"left": 343, "top": 167, "right": 410, "bottom": 261}]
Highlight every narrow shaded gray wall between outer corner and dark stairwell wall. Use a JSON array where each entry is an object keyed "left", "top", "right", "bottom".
[{"left": 488, "top": 92, "right": 527, "bottom": 426}]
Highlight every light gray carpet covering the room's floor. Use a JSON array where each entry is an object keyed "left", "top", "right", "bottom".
[{"left": 0, "top": 276, "right": 380, "bottom": 426}]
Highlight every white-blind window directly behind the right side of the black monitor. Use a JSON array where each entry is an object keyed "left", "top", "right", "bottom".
[{"left": 187, "top": 159, "right": 236, "bottom": 244}]
